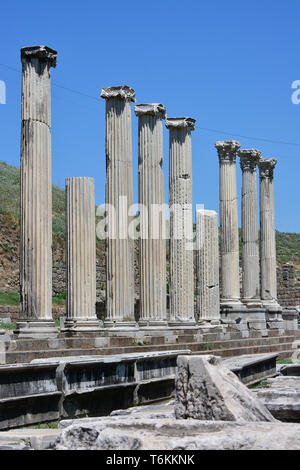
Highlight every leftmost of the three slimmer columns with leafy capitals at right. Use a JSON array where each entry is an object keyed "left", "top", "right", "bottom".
[{"left": 215, "top": 140, "right": 243, "bottom": 315}]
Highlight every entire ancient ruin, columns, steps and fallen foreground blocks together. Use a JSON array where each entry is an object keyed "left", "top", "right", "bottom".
[{"left": 0, "top": 46, "right": 300, "bottom": 450}]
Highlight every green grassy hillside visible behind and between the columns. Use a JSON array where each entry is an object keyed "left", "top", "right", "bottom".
[{"left": 0, "top": 162, "right": 300, "bottom": 291}]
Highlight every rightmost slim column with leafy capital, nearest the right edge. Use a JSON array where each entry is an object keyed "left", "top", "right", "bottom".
[{"left": 258, "top": 158, "right": 281, "bottom": 326}]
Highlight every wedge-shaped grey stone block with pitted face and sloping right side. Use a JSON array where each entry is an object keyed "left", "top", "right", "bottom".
[{"left": 175, "top": 356, "right": 275, "bottom": 422}]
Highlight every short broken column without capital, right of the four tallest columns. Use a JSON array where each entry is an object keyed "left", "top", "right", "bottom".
[{"left": 196, "top": 209, "right": 220, "bottom": 321}]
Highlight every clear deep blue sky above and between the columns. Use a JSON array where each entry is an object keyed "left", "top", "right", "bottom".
[{"left": 0, "top": 0, "right": 300, "bottom": 232}]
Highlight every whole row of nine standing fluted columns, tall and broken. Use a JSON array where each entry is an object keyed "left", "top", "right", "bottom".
[{"left": 12, "top": 46, "right": 298, "bottom": 337}]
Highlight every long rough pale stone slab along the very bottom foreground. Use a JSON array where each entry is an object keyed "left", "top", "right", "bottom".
[{"left": 56, "top": 417, "right": 300, "bottom": 450}]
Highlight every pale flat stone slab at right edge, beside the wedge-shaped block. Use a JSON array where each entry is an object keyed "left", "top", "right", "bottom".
[{"left": 255, "top": 376, "right": 300, "bottom": 423}]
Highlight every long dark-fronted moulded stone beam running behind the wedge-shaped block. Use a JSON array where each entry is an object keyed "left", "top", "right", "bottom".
[{"left": 0, "top": 349, "right": 277, "bottom": 429}]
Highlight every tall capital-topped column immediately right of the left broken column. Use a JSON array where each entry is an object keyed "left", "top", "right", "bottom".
[{"left": 101, "top": 86, "right": 135, "bottom": 326}]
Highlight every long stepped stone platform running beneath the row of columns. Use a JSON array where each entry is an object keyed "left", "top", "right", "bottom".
[{"left": 0, "top": 325, "right": 300, "bottom": 364}]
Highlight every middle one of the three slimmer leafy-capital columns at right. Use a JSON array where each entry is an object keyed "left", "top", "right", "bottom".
[{"left": 238, "top": 149, "right": 261, "bottom": 307}]
